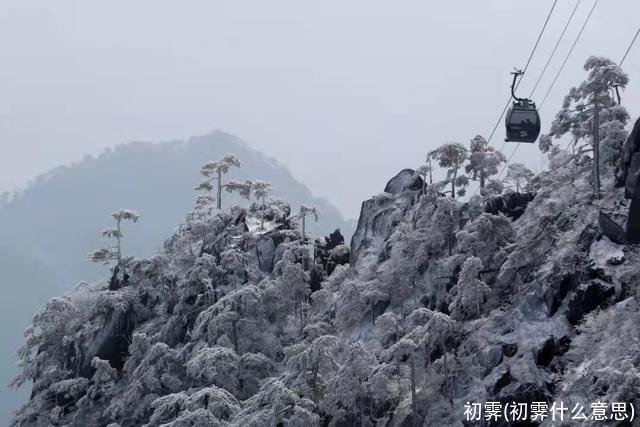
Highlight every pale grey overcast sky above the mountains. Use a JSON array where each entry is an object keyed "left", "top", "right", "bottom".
[{"left": 0, "top": 0, "right": 640, "bottom": 217}]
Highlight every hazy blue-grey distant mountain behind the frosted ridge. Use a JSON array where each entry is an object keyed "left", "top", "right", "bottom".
[{"left": 0, "top": 131, "right": 354, "bottom": 424}]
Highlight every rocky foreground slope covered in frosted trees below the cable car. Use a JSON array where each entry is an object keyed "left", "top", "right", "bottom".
[{"left": 10, "top": 135, "right": 640, "bottom": 426}]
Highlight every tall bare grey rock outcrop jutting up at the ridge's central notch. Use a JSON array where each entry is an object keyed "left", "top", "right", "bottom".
[{"left": 350, "top": 169, "right": 422, "bottom": 265}]
